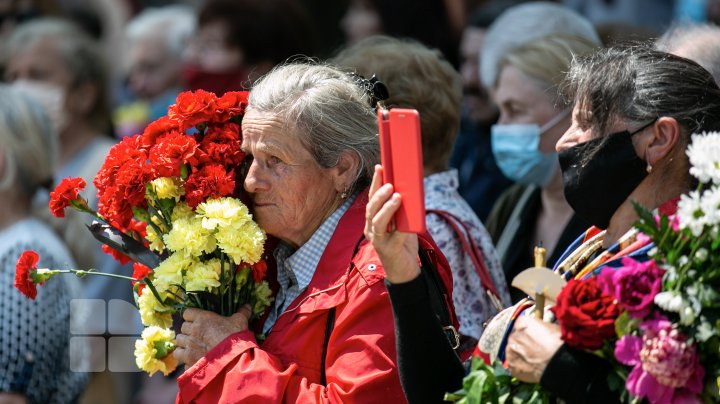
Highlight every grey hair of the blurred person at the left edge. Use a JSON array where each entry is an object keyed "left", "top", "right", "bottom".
[{"left": 0, "top": 84, "right": 58, "bottom": 197}]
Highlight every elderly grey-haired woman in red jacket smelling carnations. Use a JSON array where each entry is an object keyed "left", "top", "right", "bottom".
[{"left": 175, "top": 64, "right": 449, "bottom": 403}]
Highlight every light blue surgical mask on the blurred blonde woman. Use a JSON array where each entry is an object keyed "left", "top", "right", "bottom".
[{"left": 490, "top": 110, "right": 570, "bottom": 187}]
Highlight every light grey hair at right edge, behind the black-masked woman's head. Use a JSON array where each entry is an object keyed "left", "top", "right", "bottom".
[{"left": 655, "top": 24, "right": 720, "bottom": 83}]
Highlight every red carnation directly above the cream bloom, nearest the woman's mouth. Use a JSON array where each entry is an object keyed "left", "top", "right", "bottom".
[{"left": 185, "top": 164, "right": 235, "bottom": 209}]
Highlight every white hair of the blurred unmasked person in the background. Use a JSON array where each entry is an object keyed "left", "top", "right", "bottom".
[{"left": 125, "top": 5, "right": 197, "bottom": 58}]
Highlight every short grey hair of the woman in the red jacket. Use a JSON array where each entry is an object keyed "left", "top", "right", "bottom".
[{"left": 247, "top": 62, "right": 380, "bottom": 192}]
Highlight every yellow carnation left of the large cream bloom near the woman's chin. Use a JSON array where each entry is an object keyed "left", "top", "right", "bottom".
[{"left": 163, "top": 216, "right": 216, "bottom": 256}]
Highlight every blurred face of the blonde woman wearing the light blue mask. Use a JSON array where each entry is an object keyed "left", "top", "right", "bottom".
[{"left": 493, "top": 65, "right": 567, "bottom": 154}]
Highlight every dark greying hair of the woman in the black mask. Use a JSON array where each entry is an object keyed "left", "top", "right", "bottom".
[{"left": 563, "top": 46, "right": 720, "bottom": 168}]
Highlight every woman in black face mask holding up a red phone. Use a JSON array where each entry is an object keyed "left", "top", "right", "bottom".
[{"left": 366, "top": 48, "right": 720, "bottom": 402}]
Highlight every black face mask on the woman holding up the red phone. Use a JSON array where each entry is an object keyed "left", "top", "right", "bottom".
[{"left": 559, "top": 121, "right": 655, "bottom": 229}]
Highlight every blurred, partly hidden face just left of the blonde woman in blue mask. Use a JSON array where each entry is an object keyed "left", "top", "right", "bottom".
[{"left": 460, "top": 27, "right": 497, "bottom": 124}]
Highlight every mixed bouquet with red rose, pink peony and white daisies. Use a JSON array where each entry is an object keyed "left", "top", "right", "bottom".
[{"left": 446, "top": 133, "right": 720, "bottom": 403}]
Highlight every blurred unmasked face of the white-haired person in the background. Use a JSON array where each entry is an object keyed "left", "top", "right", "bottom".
[{"left": 128, "top": 37, "right": 186, "bottom": 100}]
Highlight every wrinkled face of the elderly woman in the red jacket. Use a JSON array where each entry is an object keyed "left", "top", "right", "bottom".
[{"left": 242, "top": 110, "right": 342, "bottom": 248}]
